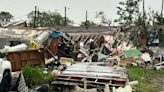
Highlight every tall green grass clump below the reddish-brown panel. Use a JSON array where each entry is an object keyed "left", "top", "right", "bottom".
[{"left": 23, "top": 65, "right": 54, "bottom": 87}]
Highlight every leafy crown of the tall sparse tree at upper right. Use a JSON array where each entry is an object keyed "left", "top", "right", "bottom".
[{"left": 115, "top": 0, "right": 141, "bottom": 28}]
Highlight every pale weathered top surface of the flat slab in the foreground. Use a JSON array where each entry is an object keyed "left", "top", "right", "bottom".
[{"left": 63, "top": 62, "right": 127, "bottom": 78}]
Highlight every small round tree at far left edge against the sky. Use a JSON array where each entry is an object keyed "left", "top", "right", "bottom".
[{"left": 0, "top": 11, "right": 13, "bottom": 26}]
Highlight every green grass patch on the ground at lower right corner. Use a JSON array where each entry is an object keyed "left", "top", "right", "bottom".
[{"left": 128, "top": 67, "right": 164, "bottom": 92}]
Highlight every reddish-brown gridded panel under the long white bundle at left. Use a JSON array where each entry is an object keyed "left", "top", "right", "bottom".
[{"left": 6, "top": 49, "right": 45, "bottom": 72}]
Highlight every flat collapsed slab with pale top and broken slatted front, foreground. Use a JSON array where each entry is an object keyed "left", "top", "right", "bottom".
[{"left": 52, "top": 62, "right": 128, "bottom": 92}]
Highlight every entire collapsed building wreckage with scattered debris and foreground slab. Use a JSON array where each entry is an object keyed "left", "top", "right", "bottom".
[{"left": 0, "top": 27, "right": 163, "bottom": 92}]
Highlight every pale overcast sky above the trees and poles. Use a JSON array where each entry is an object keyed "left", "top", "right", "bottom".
[{"left": 0, "top": 0, "right": 161, "bottom": 24}]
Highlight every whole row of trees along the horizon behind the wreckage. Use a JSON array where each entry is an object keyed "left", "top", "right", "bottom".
[{"left": 0, "top": 0, "right": 164, "bottom": 29}]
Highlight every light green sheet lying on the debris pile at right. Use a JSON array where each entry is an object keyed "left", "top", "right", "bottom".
[{"left": 124, "top": 49, "right": 142, "bottom": 58}]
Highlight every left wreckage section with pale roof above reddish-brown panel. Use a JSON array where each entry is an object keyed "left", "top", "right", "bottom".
[{"left": 0, "top": 29, "right": 50, "bottom": 71}]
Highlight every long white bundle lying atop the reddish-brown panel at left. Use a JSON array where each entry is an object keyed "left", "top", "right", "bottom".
[{"left": 2, "top": 44, "right": 27, "bottom": 53}]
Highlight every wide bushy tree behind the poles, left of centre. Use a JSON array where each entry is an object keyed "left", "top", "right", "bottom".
[{"left": 28, "top": 11, "right": 73, "bottom": 27}]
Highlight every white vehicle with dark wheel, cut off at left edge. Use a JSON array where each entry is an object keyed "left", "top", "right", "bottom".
[{"left": 0, "top": 52, "right": 12, "bottom": 92}]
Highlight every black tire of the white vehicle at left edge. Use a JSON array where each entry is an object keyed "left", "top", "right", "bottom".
[{"left": 0, "top": 72, "right": 11, "bottom": 92}]
